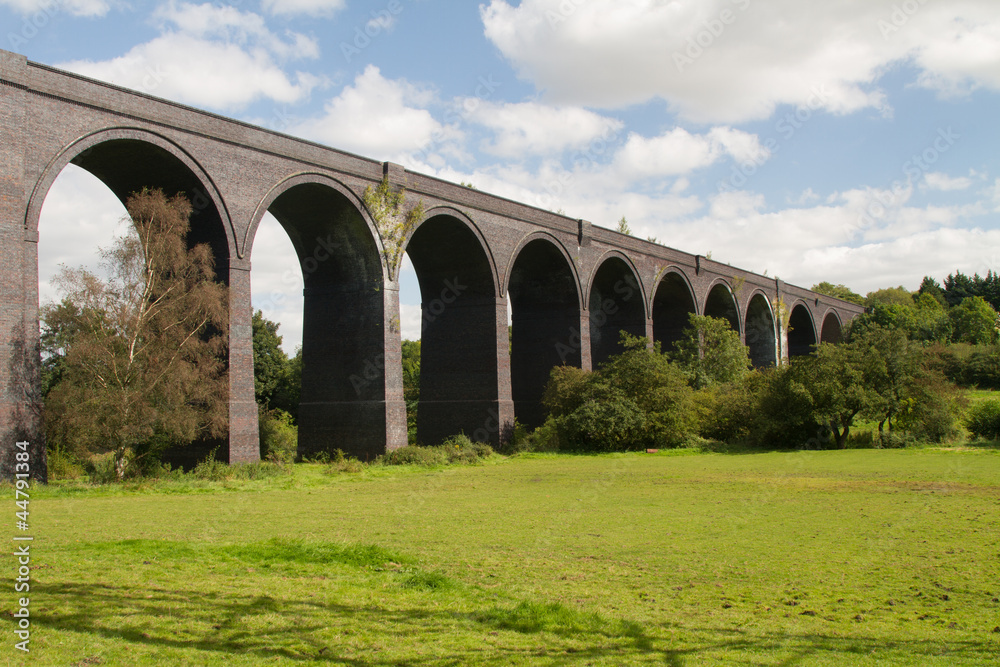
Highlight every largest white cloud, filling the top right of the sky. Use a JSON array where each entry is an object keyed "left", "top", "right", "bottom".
[{"left": 481, "top": 0, "right": 1000, "bottom": 122}]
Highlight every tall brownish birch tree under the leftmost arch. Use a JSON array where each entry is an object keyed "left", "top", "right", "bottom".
[{"left": 42, "top": 190, "right": 228, "bottom": 478}]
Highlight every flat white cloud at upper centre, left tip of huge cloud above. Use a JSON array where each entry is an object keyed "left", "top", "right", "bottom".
[{"left": 469, "top": 102, "right": 623, "bottom": 158}]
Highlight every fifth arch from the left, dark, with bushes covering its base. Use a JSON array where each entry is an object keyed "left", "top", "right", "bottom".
[{"left": 587, "top": 251, "right": 646, "bottom": 368}]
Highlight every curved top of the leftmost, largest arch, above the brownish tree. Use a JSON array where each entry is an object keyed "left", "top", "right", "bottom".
[{"left": 24, "top": 127, "right": 239, "bottom": 266}]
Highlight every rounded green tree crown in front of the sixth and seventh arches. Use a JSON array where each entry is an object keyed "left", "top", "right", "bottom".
[{"left": 670, "top": 313, "right": 750, "bottom": 389}]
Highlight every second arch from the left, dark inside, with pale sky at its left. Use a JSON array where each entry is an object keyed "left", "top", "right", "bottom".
[{"left": 250, "top": 174, "right": 390, "bottom": 459}]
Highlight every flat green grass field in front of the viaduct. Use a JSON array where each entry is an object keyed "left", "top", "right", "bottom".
[{"left": 7, "top": 447, "right": 1000, "bottom": 666}]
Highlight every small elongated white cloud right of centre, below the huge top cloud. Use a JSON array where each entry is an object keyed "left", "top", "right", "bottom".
[{"left": 614, "top": 127, "right": 770, "bottom": 178}]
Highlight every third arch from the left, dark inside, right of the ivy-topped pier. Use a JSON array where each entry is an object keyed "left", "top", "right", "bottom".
[{"left": 405, "top": 209, "right": 507, "bottom": 445}]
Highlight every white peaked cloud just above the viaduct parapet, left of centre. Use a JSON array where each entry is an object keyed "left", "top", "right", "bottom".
[{"left": 292, "top": 65, "right": 447, "bottom": 159}]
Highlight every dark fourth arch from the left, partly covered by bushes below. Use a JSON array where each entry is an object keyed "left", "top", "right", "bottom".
[{"left": 506, "top": 233, "right": 583, "bottom": 427}]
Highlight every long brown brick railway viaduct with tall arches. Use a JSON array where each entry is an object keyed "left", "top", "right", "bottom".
[{"left": 0, "top": 51, "right": 860, "bottom": 475}]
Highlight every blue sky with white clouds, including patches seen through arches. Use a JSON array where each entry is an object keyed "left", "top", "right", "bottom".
[{"left": 13, "top": 0, "right": 1000, "bottom": 351}]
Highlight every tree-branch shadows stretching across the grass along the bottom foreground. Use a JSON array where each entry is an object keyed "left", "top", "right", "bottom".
[{"left": 32, "top": 583, "right": 996, "bottom": 666}]
